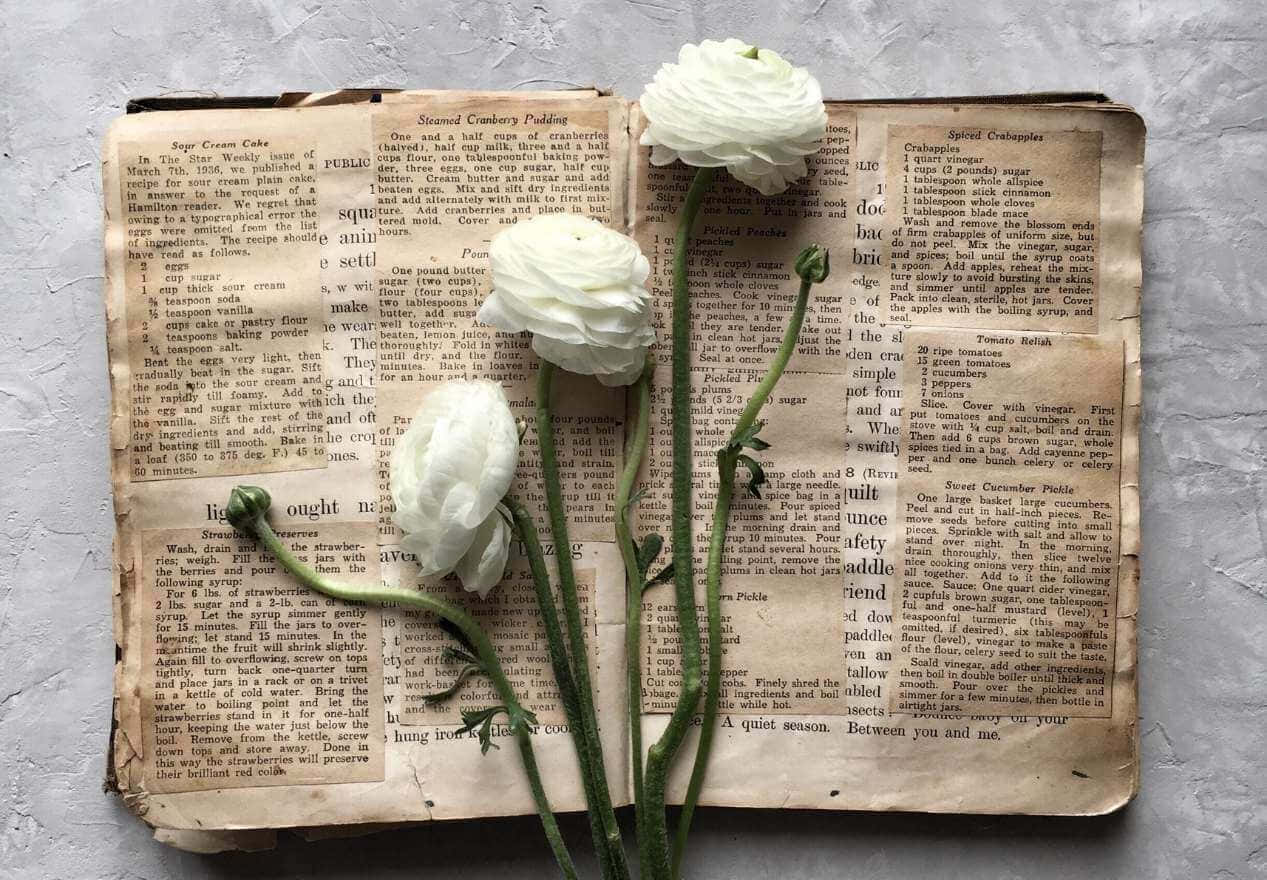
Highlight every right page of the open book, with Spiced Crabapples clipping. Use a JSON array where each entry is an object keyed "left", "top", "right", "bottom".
[{"left": 631, "top": 104, "right": 1143, "bottom": 814}]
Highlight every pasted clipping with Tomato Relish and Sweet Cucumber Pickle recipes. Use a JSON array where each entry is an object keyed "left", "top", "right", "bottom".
[{"left": 892, "top": 330, "right": 1121, "bottom": 718}]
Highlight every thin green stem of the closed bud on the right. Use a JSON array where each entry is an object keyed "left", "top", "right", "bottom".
[{"left": 673, "top": 281, "right": 812, "bottom": 880}]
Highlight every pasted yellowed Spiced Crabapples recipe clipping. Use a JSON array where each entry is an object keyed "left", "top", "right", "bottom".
[{"left": 868, "top": 125, "right": 1100, "bottom": 333}]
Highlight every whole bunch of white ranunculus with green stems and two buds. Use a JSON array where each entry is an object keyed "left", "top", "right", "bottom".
[{"left": 227, "top": 39, "right": 829, "bottom": 880}]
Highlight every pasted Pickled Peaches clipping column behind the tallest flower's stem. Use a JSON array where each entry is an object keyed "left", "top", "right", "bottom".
[{"left": 631, "top": 106, "right": 855, "bottom": 724}]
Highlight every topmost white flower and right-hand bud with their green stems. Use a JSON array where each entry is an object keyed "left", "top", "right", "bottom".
[{"left": 639, "top": 39, "right": 829, "bottom": 880}]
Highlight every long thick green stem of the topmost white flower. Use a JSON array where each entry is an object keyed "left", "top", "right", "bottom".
[{"left": 645, "top": 162, "right": 715, "bottom": 880}]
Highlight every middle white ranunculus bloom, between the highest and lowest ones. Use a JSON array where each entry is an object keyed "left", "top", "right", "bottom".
[{"left": 475, "top": 214, "right": 655, "bottom": 385}]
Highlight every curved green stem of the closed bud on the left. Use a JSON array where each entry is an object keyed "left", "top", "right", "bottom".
[{"left": 253, "top": 517, "right": 576, "bottom": 880}]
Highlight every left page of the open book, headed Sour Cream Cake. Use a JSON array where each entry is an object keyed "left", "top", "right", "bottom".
[{"left": 104, "top": 91, "right": 628, "bottom": 842}]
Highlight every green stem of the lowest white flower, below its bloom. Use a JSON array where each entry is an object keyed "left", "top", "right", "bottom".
[{"left": 502, "top": 495, "right": 613, "bottom": 877}]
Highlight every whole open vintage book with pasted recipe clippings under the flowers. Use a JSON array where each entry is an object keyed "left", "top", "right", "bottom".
[{"left": 104, "top": 91, "right": 1144, "bottom": 848}]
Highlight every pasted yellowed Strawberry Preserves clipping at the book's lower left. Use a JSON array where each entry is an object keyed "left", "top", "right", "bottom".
[{"left": 141, "top": 524, "right": 383, "bottom": 791}]
